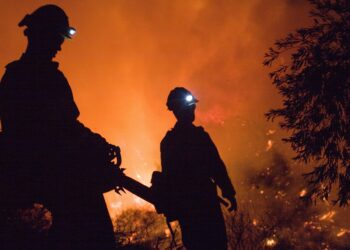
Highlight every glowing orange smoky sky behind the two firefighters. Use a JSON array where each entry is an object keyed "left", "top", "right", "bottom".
[{"left": 0, "top": 0, "right": 309, "bottom": 217}]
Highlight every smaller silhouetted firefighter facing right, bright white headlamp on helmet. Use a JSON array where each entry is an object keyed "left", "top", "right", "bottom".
[{"left": 159, "top": 87, "right": 237, "bottom": 250}]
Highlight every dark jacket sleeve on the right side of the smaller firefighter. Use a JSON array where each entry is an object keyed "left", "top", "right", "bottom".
[{"left": 205, "top": 132, "right": 236, "bottom": 198}]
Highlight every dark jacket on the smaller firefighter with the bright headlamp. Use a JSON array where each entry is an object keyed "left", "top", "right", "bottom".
[{"left": 161, "top": 123, "right": 235, "bottom": 215}]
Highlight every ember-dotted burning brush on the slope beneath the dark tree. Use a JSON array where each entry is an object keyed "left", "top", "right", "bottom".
[{"left": 221, "top": 150, "right": 350, "bottom": 249}]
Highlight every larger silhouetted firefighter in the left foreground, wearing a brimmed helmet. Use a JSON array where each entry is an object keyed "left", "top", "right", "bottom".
[{"left": 0, "top": 5, "right": 120, "bottom": 249}]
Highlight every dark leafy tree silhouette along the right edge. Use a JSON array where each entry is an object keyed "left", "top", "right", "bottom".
[{"left": 264, "top": 0, "right": 350, "bottom": 206}]
